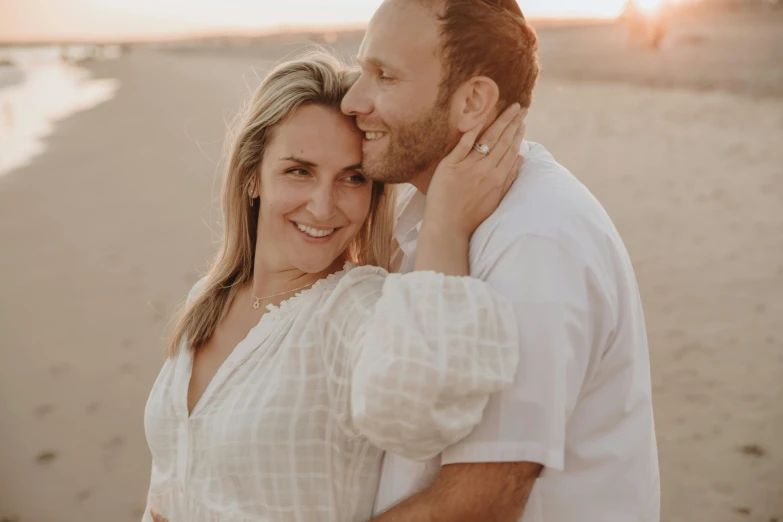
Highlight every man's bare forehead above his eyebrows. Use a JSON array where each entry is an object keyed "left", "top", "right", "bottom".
[{"left": 359, "top": 0, "right": 439, "bottom": 68}]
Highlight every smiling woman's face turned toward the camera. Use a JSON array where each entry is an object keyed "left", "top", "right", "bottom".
[{"left": 254, "top": 105, "right": 372, "bottom": 274}]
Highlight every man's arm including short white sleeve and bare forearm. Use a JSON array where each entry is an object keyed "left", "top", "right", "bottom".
[{"left": 373, "top": 234, "right": 604, "bottom": 522}]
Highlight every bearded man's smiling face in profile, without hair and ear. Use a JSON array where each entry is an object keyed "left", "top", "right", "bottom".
[{"left": 342, "top": 0, "right": 459, "bottom": 183}]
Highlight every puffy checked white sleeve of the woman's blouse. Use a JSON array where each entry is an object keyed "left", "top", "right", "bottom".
[{"left": 324, "top": 269, "right": 518, "bottom": 460}]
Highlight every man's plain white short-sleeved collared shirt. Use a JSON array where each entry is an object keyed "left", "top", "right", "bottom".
[{"left": 375, "top": 142, "right": 660, "bottom": 522}]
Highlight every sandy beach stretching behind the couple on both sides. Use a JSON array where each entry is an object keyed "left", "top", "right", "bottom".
[{"left": 0, "top": 10, "right": 783, "bottom": 522}]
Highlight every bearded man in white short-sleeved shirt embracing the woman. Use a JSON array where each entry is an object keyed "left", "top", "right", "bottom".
[{"left": 343, "top": 0, "right": 660, "bottom": 522}]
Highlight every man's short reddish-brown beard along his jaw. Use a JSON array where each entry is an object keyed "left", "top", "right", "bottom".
[{"left": 362, "top": 104, "right": 457, "bottom": 183}]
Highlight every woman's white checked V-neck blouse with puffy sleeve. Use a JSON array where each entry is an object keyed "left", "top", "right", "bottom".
[{"left": 143, "top": 264, "right": 518, "bottom": 522}]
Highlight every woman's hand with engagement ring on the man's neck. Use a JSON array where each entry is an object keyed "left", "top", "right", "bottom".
[{"left": 422, "top": 103, "right": 525, "bottom": 239}]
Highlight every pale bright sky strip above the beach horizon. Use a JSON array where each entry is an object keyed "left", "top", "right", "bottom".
[{"left": 0, "top": 0, "right": 636, "bottom": 41}]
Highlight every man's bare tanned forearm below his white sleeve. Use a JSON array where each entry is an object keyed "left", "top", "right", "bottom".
[{"left": 372, "top": 462, "right": 542, "bottom": 522}]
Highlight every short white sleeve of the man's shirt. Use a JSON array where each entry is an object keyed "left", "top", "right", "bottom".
[{"left": 441, "top": 235, "right": 603, "bottom": 470}]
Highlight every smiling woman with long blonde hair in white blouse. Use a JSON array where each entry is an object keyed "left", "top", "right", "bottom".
[{"left": 145, "top": 51, "right": 521, "bottom": 522}]
